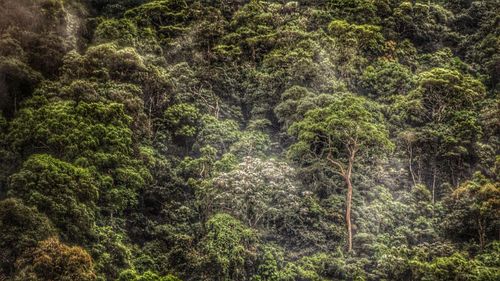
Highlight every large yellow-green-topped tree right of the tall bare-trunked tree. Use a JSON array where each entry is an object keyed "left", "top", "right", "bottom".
[{"left": 398, "top": 68, "right": 485, "bottom": 188}]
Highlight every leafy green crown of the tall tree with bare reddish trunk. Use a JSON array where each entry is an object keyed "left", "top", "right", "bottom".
[{"left": 289, "top": 94, "right": 393, "bottom": 163}]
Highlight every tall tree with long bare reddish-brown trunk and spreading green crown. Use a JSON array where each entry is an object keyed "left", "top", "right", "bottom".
[{"left": 289, "top": 94, "right": 393, "bottom": 252}]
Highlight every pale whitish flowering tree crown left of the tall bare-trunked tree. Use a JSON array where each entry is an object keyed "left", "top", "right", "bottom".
[{"left": 207, "top": 157, "right": 300, "bottom": 228}]
